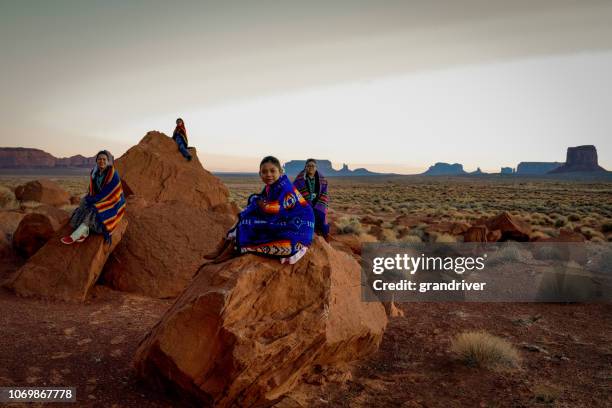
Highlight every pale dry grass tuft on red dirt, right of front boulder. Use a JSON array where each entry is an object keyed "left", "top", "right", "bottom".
[{"left": 451, "top": 331, "right": 520, "bottom": 369}]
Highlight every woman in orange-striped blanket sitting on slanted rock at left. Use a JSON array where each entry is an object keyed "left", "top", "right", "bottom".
[{"left": 61, "top": 150, "right": 125, "bottom": 245}]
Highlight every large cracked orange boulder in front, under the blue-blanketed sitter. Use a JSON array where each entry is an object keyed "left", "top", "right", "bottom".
[{"left": 135, "top": 237, "right": 387, "bottom": 407}]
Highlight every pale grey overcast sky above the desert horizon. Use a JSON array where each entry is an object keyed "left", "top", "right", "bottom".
[{"left": 0, "top": 0, "right": 612, "bottom": 173}]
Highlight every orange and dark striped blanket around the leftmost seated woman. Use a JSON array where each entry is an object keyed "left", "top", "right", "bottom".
[{"left": 86, "top": 166, "right": 125, "bottom": 241}]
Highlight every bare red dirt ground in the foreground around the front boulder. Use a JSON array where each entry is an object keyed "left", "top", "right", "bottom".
[{"left": 0, "top": 278, "right": 612, "bottom": 407}]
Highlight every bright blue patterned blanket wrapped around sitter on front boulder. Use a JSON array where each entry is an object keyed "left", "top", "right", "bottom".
[{"left": 236, "top": 175, "right": 314, "bottom": 257}]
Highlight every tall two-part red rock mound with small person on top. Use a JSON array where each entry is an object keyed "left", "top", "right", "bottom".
[{"left": 103, "top": 132, "right": 238, "bottom": 298}]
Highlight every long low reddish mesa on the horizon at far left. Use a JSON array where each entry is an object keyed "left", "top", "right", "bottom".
[{"left": 0, "top": 147, "right": 96, "bottom": 169}]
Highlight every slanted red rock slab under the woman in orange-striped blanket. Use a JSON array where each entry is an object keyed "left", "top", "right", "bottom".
[{"left": 6, "top": 218, "right": 128, "bottom": 301}]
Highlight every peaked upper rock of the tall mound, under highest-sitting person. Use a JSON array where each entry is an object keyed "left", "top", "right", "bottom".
[{"left": 115, "top": 132, "right": 229, "bottom": 209}]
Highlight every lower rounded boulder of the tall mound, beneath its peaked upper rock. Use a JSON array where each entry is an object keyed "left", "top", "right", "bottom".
[{"left": 104, "top": 198, "right": 235, "bottom": 298}]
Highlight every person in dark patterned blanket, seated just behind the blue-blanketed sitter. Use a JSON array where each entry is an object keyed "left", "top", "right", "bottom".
[{"left": 293, "top": 159, "right": 329, "bottom": 240}]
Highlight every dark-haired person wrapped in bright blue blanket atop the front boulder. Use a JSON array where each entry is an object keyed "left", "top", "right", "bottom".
[{"left": 205, "top": 156, "right": 315, "bottom": 264}]
